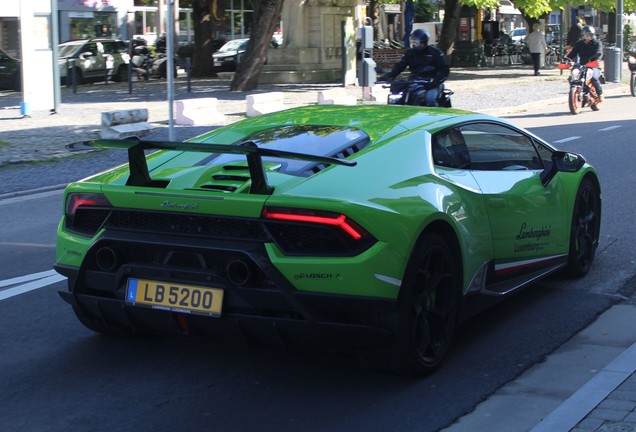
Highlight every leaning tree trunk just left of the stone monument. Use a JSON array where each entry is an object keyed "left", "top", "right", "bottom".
[{"left": 230, "top": 0, "right": 283, "bottom": 91}]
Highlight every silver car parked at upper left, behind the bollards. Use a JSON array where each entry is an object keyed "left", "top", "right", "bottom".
[{"left": 59, "top": 38, "right": 130, "bottom": 84}]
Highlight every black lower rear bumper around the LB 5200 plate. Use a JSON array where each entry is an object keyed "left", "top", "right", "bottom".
[{"left": 56, "top": 266, "right": 396, "bottom": 349}]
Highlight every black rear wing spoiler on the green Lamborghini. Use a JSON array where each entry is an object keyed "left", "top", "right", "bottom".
[{"left": 89, "top": 138, "right": 357, "bottom": 194}]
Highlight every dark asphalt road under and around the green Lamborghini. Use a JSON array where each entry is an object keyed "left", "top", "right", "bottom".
[{"left": 0, "top": 96, "right": 636, "bottom": 432}]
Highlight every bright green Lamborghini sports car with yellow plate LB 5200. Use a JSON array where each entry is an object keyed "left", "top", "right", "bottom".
[{"left": 55, "top": 105, "right": 601, "bottom": 374}]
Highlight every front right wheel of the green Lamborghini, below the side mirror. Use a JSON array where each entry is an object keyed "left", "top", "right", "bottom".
[{"left": 567, "top": 178, "right": 601, "bottom": 277}]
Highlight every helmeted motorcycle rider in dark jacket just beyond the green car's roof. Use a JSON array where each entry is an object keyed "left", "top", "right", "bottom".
[{"left": 380, "top": 29, "right": 450, "bottom": 106}]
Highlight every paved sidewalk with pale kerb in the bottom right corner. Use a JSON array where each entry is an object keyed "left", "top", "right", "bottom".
[{"left": 443, "top": 299, "right": 636, "bottom": 432}]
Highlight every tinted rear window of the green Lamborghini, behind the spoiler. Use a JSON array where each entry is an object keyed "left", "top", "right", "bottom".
[{"left": 199, "top": 125, "right": 369, "bottom": 176}]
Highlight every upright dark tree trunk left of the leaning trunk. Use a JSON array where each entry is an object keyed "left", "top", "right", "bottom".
[{"left": 192, "top": 0, "right": 217, "bottom": 77}]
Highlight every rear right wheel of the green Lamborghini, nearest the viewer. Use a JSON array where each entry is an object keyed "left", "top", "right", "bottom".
[{"left": 358, "top": 232, "right": 461, "bottom": 375}]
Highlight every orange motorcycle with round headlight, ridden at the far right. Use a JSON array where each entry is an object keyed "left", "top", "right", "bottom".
[{"left": 558, "top": 60, "right": 602, "bottom": 115}]
